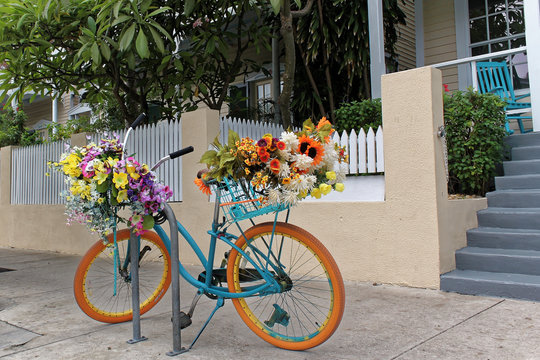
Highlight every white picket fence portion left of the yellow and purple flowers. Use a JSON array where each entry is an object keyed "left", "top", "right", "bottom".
[{"left": 11, "top": 140, "right": 69, "bottom": 204}]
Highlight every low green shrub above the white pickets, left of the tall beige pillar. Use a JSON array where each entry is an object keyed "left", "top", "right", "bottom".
[{"left": 334, "top": 99, "right": 382, "bottom": 133}]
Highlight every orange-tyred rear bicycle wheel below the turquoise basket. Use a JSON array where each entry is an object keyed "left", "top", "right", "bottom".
[{"left": 227, "top": 222, "right": 345, "bottom": 350}]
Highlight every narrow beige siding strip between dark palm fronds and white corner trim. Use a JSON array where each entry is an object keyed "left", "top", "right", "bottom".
[{"left": 395, "top": 0, "right": 416, "bottom": 71}]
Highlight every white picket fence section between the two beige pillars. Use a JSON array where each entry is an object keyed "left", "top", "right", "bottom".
[{"left": 219, "top": 117, "right": 384, "bottom": 174}]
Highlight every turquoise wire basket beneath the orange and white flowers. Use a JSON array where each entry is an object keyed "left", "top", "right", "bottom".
[{"left": 212, "top": 178, "right": 288, "bottom": 223}]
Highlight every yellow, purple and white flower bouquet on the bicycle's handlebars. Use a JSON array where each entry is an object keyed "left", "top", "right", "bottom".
[{"left": 49, "top": 139, "right": 172, "bottom": 236}]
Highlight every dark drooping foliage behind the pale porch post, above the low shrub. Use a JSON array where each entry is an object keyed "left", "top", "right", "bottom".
[{"left": 292, "top": 0, "right": 405, "bottom": 121}]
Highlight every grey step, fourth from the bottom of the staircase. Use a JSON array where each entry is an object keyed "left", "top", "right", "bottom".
[{"left": 476, "top": 207, "right": 540, "bottom": 230}]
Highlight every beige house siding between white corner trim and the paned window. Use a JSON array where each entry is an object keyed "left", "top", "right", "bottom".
[{"left": 423, "top": 0, "right": 458, "bottom": 90}]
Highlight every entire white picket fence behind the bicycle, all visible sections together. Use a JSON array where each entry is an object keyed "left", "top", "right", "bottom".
[{"left": 11, "top": 118, "right": 384, "bottom": 204}]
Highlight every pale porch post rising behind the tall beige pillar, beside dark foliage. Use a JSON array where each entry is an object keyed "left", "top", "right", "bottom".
[{"left": 368, "top": 0, "right": 386, "bottom": 99}]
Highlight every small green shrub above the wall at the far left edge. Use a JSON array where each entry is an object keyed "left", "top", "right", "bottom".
[{"left": 0, "top": 107, "right": 41, "bottom": 147}]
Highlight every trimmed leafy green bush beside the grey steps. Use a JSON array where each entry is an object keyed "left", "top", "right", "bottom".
[{"left": 444, "top": 89, "right": 506, "bottom": 196}]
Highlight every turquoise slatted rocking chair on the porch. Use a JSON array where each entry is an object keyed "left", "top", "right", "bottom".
[{"left": 476, "top": 62, "right": 532, "bottom": 134}]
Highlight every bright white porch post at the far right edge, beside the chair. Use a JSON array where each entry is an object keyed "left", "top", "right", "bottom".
[{"left": 524, "top": 0, "right": 540, "bottom": 131}]
